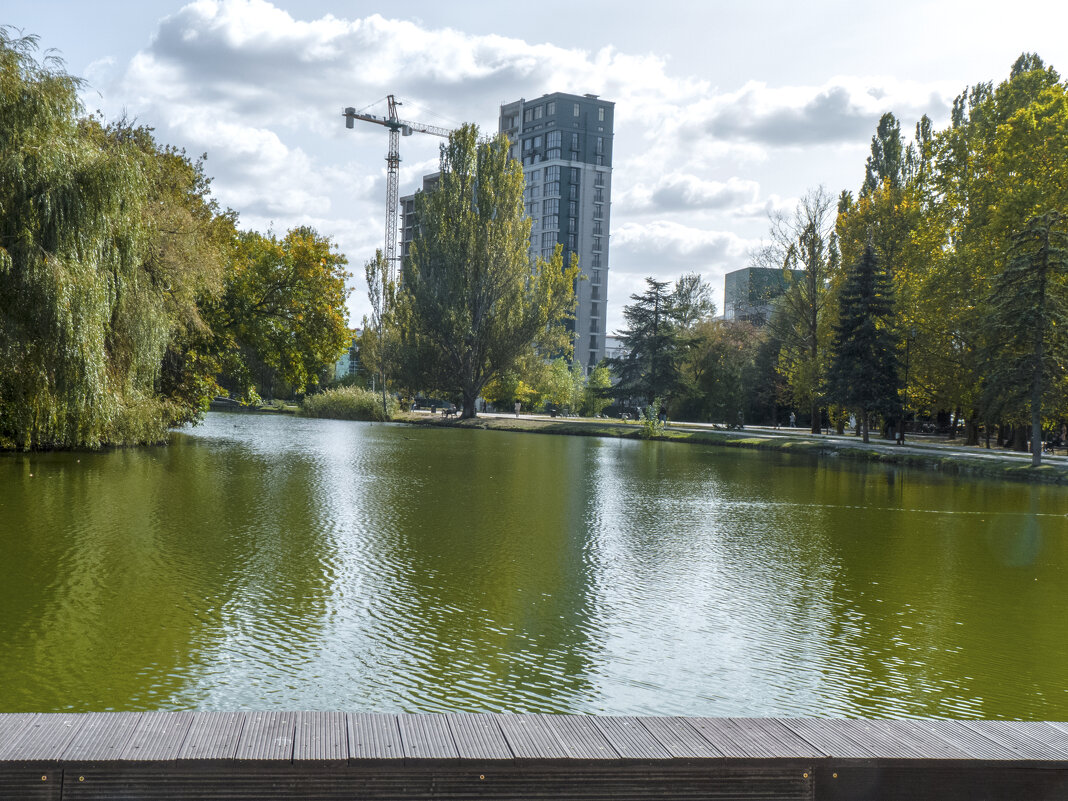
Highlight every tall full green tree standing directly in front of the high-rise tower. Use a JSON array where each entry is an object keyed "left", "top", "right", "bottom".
[{"left": 398, "top": 125, "right": 579, "bottom": 418}]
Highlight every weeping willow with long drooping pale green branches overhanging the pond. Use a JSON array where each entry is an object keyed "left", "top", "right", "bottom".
[{"left": 0, "top": 29, "right": 160, "bottom": 449}]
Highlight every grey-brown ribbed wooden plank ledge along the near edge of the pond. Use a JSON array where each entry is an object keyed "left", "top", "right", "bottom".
[{"left": 0, "top": 711, "right": 1068, "bottom": 801}]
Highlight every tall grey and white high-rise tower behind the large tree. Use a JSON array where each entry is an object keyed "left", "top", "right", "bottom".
[{"left": 499, "top": 92, "right": 615, "bottom": 371}]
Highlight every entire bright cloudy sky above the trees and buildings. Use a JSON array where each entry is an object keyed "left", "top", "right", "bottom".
[{"left": 6, "top": 0, "right": 1068, "bottom": 331}]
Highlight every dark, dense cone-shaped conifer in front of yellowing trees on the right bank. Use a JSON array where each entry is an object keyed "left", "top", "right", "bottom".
[{"left": 829, "top": 245, "right": 900, "bottom": 442}]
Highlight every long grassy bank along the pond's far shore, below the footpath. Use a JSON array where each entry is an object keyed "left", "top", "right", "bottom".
[{"left": 395, "top": 412, "right": 1068, "bottom": 484}]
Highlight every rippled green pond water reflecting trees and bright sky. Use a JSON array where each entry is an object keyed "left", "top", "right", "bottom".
[{"left": 0, "top": 414, "right": 1068, "bottom": 720}]
